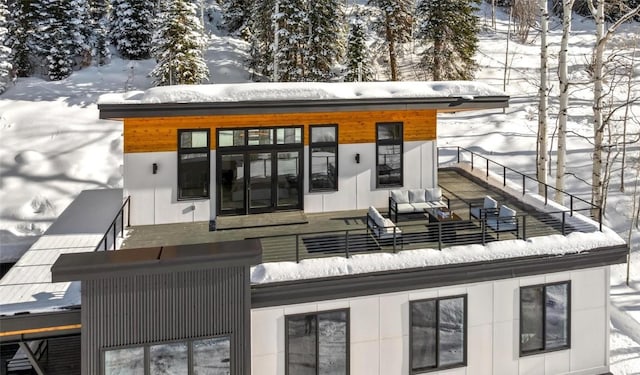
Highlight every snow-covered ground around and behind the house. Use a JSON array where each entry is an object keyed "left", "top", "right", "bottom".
[{"left": 0, "top": 2, "right": 640, "bottom": 374}]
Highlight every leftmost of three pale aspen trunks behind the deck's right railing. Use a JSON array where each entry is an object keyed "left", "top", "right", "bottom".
[{"left": 537, "top": 0, "right": 549, "bottom": 195}]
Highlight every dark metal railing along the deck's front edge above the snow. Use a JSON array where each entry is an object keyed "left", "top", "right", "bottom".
[{"left": 254, "top": 210, "right": 597, "bottom": 263}]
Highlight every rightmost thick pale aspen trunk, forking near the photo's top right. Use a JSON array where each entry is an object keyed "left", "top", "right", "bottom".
[{"left": 587, "top": 0, "right": 640, "bottom": 214}]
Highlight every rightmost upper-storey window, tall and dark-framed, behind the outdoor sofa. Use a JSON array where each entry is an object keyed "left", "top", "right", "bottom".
[{"left": 376, "top": 123, "right": 403, "bottom": 187}]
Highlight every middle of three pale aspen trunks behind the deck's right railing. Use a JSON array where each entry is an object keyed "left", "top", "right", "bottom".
[{"left": 555, "top": 0, "right": 575, "bottom": 204}]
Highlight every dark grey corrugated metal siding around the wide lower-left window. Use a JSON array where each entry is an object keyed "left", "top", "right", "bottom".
[{"left": 82, "top": 267, "right": 250, "bottom": 374}]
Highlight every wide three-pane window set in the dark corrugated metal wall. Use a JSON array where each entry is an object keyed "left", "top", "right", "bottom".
[{"left": 103, "top": 336, "right": 231, "bottom": 375}]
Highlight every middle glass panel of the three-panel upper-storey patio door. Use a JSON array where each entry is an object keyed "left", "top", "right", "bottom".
[{"left": 249, "top": 152, "right": 273, "bottom": 212}]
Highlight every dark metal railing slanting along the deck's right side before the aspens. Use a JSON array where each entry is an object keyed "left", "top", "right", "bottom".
[{"left": 438, "top": 147, "right": 602, "bottom": 231}]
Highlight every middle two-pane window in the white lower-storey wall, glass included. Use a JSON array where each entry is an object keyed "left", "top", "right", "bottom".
[{"left": 409, "top": 296, "right": 467, "bottom": 374}]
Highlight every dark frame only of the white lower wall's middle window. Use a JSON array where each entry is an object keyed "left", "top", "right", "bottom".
[{"left": 409, "top": 294, "right": 469, "bottom": 374}]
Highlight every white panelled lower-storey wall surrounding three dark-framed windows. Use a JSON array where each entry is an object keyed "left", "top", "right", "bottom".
[{"left": 251, "top": 267, "right": 609, "bottom": 375}]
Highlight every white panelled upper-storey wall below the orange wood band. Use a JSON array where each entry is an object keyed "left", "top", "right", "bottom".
[{"left": 124, "top": 141, "right": 437, "bottom": 225}]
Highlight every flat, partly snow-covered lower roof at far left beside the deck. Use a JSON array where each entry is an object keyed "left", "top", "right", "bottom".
[{"left": 0, "top": 189, "right": 122, "bottom": 315}]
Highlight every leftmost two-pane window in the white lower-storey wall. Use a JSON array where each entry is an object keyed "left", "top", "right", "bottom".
[{"left": 285, "top": 310, "right": 349, "bottom": 375}]
